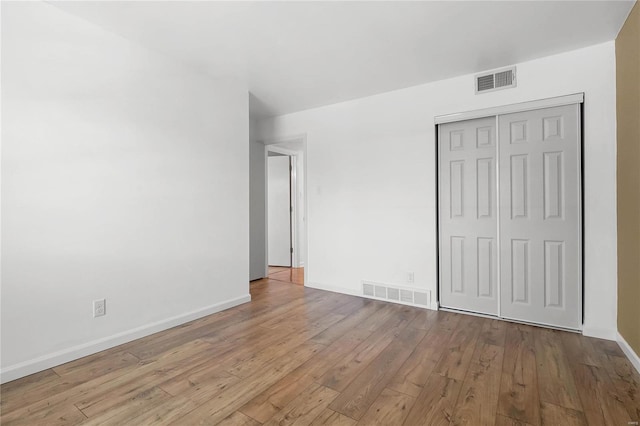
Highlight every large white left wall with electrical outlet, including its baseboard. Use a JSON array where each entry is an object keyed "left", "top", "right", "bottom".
[{"left": 1, "top": 3, "right": 250, "bottom": 381}]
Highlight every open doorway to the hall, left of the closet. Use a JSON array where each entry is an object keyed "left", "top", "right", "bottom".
[{"left": 265, "top": 137, "right": 307, "bottom": 285}]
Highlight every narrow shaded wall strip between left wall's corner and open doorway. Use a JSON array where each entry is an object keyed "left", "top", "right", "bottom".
[{"left": 249, "top": 120, "right": 267, "bottom": 280}]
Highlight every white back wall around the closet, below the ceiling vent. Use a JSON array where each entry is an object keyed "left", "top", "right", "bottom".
[{"left": 259, "top": 42, "right": 616, "bottom": 339}]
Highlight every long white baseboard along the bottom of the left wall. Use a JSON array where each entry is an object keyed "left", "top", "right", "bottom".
[{"left": 0, "top": 294, "right": 251, "bottom": 383}]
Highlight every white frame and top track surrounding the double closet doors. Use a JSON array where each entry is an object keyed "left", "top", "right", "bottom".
[{"left": 434, "top": 92, "right": 584, "bottom": 332}]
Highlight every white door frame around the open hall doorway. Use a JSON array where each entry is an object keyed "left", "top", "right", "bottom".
[{"left": 261, "top": 134, "right": 309, "bottom": 285}]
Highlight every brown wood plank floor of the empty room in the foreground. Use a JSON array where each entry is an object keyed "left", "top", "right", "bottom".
[{"left": 0, "top": 271, "right": 640, "bottom": 426}]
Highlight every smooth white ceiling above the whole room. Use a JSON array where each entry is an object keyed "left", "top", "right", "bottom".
[{"left": 53, "top": 1, "right": 634, "bottom": 118}]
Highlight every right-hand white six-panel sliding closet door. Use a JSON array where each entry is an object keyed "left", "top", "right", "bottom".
[{"left": 498, "top": 105, "right": 582, "bottom": 329}]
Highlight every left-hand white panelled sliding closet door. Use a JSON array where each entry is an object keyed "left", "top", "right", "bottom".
[{"left": 438, "top": 117, "right": 498, "bottom": 315}]
